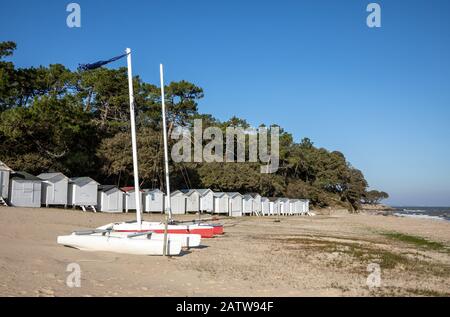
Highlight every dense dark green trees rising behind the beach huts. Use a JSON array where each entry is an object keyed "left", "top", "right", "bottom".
[{"left": 0, "top": 42, "right": 386, "bottom": 211}]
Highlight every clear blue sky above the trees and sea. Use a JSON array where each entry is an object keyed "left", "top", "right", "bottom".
[{"left": 0, "top": 0, "right": 450, "bottom": 206}]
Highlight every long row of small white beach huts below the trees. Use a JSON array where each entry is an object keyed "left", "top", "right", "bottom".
[{"left": 0, "top": 162, "right": 309, "bottom": 217}]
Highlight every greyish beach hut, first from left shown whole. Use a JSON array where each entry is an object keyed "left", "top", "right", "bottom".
[{"left": 9, "top": 172, "right": 41, "bottom": 207}]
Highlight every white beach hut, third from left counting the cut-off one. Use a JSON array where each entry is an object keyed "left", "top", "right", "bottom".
[{"left": 37, "top": 173, "right": 69, "bottom": 207}]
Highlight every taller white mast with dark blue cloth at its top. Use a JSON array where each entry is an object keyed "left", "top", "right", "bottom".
[{"left": 126, "top": 48, "right": 142, "bottom": 230}]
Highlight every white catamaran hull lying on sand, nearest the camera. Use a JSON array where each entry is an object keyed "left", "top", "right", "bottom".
[{"left": 57, "top": 234, "right": 181, "bottom": 255}]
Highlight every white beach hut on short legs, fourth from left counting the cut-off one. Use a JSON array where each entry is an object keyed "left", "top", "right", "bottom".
[{"left": 67, "top": 177, "right": 99, "bottom": 211}]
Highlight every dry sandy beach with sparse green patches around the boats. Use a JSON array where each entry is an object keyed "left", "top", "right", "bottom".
[{"left": 0, "top": 207, "right": 450, "bottom": 297}]
